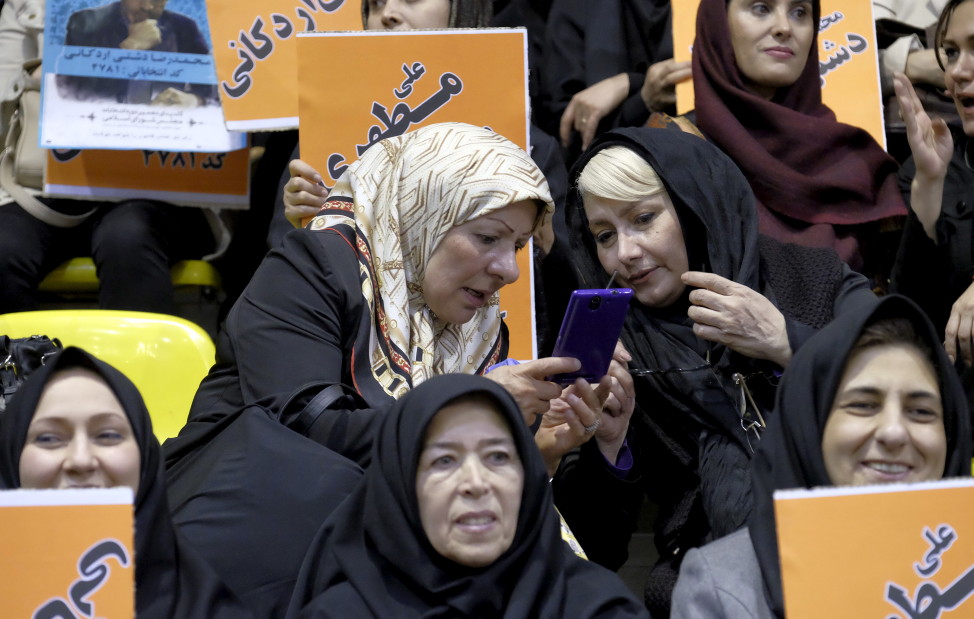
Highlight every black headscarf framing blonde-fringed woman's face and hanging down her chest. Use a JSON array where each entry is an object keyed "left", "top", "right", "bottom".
[{"left": 566, "top": 128, "right": 770, "bottom": 460}]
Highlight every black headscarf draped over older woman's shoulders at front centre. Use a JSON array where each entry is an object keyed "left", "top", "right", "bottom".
[{"left": 289, "top": 374, "right": 647, "bottom": 617}]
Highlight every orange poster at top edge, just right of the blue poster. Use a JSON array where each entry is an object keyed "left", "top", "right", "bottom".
[{"left": 206, "top": 0, "right": 362, "bottom": 131}]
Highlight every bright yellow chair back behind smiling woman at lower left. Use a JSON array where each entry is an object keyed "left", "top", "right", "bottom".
[{"left": 0, "top": 310, "right": 216, "bottom": 442}]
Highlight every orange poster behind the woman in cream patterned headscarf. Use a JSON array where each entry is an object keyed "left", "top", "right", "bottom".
[{"left": 298, "top": 28, "right": 536, "bottom": 360}]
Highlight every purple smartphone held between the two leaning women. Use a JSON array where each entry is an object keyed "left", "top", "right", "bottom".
[{"left": 548, "top": 288, "right": 632, "bottom": 385}]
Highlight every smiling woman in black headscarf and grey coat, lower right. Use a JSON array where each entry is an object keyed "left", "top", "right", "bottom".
[{"left": 673, "top": 295, "right": 971, "bottom": 617}]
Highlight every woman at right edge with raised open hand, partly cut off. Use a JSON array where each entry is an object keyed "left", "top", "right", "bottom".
[{"left": 892, "top": 0, "right": 974, "bottom": 366}]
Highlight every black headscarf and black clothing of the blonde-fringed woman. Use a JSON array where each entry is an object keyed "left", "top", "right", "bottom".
[{"left": 563, "top": 128, "right": 873, "bottom": 615}]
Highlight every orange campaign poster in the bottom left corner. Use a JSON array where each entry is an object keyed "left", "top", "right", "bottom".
[{"left": 0, "top": 488, "right": 135, "bottom": 619}]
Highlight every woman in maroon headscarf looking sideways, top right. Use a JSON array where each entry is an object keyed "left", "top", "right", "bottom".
[{"left": 693, "top": 0, "right": 906, "bottom": 275}]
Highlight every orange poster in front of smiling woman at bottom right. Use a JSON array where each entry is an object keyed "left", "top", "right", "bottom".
[{"left": 774, "top": 478, "right": 974, "bottom": 619}]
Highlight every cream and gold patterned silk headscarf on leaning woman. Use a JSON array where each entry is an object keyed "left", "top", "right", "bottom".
[{"left": 309, "top": 123, "right": 554, "bottom": 398}]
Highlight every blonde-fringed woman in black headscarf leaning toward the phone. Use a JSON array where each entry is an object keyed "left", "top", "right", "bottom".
[{"left": 555, "top": 128, "right": 873, "bottom": 616}]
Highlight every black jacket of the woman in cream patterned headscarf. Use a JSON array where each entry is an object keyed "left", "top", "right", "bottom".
[{"left": 189, "top": 229, "right": 393, "bottom": 467}]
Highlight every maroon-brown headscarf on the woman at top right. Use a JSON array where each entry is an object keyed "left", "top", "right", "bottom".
[{"left": 693, "top": 0, "right": 906, "bottom": 267}]
